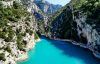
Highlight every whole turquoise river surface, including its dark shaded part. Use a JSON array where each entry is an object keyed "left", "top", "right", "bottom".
[{"left": 18, "top": 37, "right": 100, "bottom": 64}]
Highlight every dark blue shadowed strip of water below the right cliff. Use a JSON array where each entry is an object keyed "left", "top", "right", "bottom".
[{"left": 41, "top": 36, "right": 100, "bottom": 64}]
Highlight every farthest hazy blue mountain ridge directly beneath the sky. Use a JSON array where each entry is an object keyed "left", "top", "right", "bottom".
[{"left": 34, "top": 0, "right": 62, "bottom": 15}]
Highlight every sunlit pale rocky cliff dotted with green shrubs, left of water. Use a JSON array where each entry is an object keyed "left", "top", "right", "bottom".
[{"left": 0, "top": 0, "right": 38, "bottom": 64}]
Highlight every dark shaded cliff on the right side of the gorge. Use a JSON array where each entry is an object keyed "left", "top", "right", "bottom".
[{"left": 46, "top": 0, "right": 100, "bottom": 58}]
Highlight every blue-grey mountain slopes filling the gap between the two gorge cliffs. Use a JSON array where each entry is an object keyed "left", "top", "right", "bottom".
[{"left": 32, "top": 0, "right": 62, "bottom": 33}]
